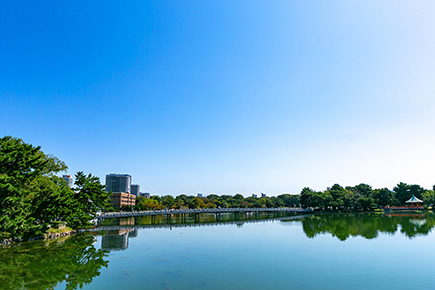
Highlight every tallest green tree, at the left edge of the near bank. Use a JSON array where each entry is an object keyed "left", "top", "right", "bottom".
[{"left": 0, "top": 136, "right": 67, "bottom": 238}]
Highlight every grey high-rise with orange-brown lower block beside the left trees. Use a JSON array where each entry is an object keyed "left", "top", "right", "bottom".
[{"left": 106, "top": 173, "right": 136, "bottom": 208}]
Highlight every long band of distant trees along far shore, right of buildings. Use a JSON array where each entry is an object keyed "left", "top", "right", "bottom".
[{"left": 136, "top": 182, "right": 435, "bottom": 210}]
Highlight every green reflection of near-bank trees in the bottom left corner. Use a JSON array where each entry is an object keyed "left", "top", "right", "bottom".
[{"left": 0, "top": 235, "right": 109, "bottom": 289}]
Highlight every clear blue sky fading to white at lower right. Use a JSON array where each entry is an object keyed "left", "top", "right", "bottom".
[{"left": 0, "top": 0, "right": 435, "bottom": 195}]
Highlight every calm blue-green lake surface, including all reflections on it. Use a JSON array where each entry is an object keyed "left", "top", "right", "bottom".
[{"left": 0, "top": 213, "right": 435, "bottom": 289}]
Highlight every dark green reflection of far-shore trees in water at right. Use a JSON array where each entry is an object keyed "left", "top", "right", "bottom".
[{"left": 288, "top": 213, "right": 435, "bottom": 241}]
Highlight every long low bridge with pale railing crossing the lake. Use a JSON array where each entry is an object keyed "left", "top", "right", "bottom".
[{"left": 97, "top": 207, "right": 313, "bottom": 219}]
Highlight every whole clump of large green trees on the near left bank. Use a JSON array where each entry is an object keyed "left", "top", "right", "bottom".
[{"left": 0, "top": 136, "right": 110, "bottom": 240}]
